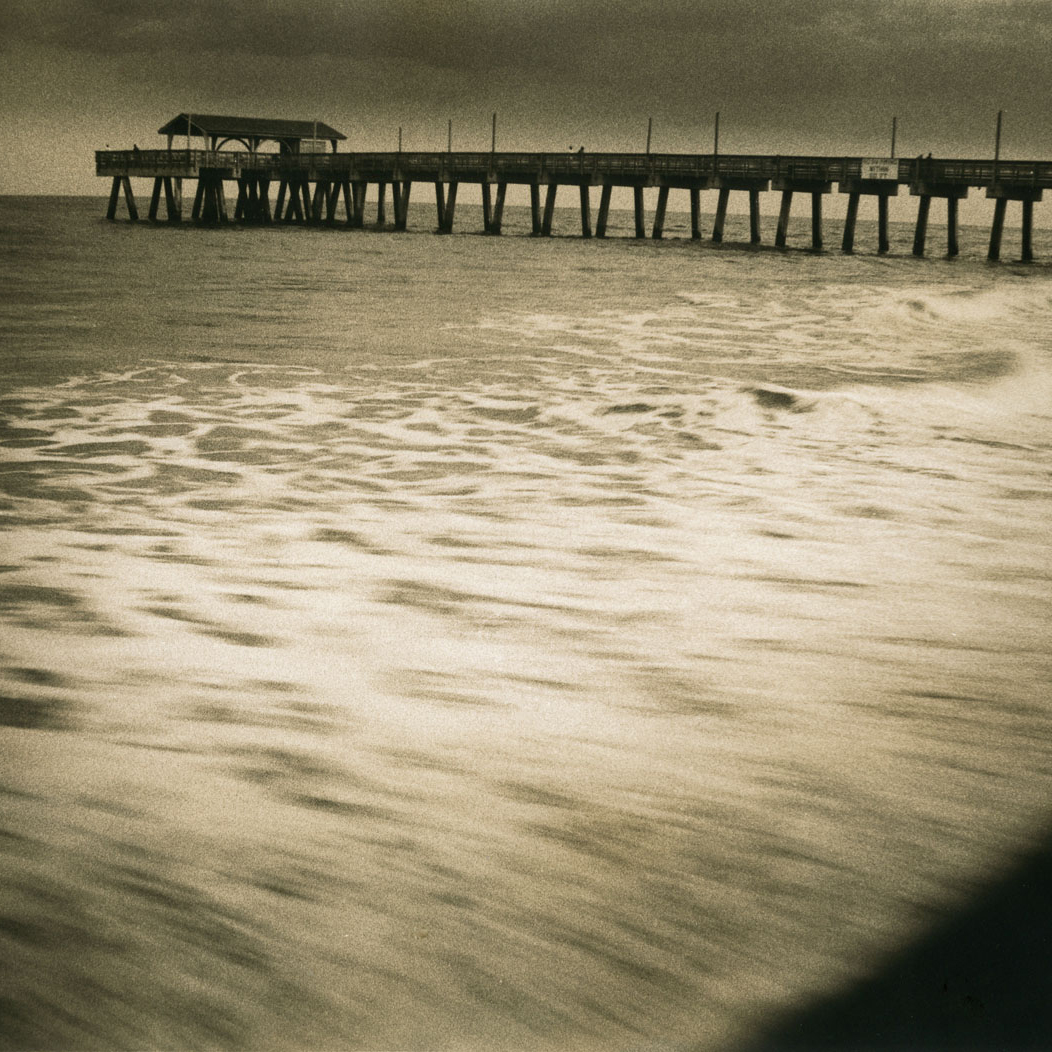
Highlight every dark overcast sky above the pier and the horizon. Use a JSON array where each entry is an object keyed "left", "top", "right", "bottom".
[{"left": 0, "top": 0, "right": 1052, "bottom": 194}]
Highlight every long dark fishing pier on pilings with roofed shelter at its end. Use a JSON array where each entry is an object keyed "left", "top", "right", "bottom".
[{"left": 96, "top": 114, "right": 1052, "bottom": 262}]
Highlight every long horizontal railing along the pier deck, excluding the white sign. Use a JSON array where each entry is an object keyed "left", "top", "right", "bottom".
[{"left": 96, "top": 149, "right": 1052, "bottom": 189}]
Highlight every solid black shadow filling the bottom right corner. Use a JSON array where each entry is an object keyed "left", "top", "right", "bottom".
[{"left": 746, "top": 834, "right": 1052, "bottom": 1052}]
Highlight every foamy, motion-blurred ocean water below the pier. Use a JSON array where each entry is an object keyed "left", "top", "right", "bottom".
[{"left": 0, "top": 199, "right": 1052, "bottom": 1052}]
